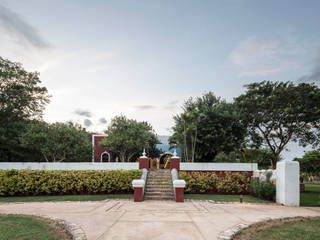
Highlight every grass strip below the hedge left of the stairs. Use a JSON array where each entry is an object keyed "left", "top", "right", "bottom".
[{"left": 0, "top": 194, "right": 133, "bottom": 202}]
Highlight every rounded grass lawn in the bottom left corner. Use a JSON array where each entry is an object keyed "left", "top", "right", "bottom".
[{"left": 0, "top": 216, "right": 72, "bottom": 240}]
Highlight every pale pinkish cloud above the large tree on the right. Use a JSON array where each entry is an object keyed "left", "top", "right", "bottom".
[{"left": 230, "top": 37, "right": 298, "bottom": 77}]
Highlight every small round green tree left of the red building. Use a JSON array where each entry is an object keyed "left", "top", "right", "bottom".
[{"left": 20, "top": 121, "right": 92, "bottom": 162}]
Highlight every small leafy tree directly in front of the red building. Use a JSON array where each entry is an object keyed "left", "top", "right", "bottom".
[{"left": 99, "top": 116, "right": 158, "bottom": 162}]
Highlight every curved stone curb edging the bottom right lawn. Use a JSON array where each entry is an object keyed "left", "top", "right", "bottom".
[{"left": 218, "top": 216, "right": 300, "bottom": 240}]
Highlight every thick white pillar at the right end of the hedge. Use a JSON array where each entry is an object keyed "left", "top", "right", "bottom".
[{"left": 276, "top": 161, "right": 300, "bottom": 206}]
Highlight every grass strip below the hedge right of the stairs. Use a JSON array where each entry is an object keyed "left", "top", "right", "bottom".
[{"left": 184, "top": 194, "right": 271, "bottom": 203}]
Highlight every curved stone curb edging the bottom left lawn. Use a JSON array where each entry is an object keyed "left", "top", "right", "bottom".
[{"left": 1, "top": 214, "right": 87, "bottom": 240}]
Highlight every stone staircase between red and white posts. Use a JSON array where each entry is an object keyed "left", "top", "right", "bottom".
[{"left": 144, "top": 169, "right": 173, "bottom": 200}]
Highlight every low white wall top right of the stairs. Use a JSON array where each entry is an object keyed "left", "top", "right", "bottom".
[{"left": 180, "top": 162, "right": 258, "bottom": 171}]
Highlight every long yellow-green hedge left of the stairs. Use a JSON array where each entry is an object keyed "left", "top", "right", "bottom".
[{"left": 0, "top": 170, "right": 141, "bottom": 196}]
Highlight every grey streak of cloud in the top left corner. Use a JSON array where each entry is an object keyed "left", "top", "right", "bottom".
[{"left": 0, "top": 5, "right": 49, "bottom": 48}]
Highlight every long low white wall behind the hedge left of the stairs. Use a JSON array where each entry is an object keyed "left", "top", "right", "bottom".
[{"left": 0, "top": 162, "right": 139, "bottom": 170}]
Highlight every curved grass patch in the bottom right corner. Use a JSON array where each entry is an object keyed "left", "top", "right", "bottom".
[{"left": 251, "top": 218, "right": 320, "bottom": 240}]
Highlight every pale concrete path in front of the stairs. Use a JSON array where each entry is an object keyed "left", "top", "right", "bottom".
[{"left": 0, "top": 200, "right": 320, "bottom": 240}]
